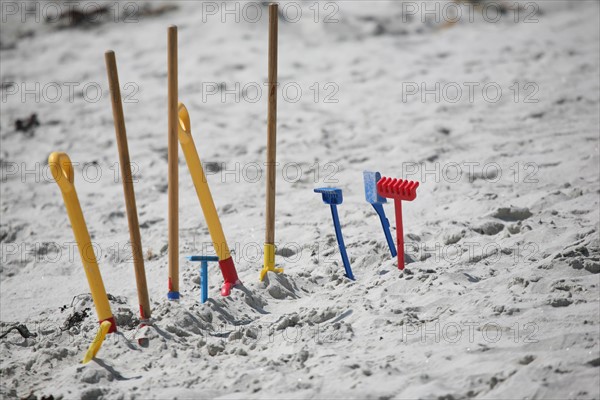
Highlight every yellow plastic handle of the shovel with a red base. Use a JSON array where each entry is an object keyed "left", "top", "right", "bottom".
[{"left": 178, "top": 103, "right": 231, "bottom": 260}]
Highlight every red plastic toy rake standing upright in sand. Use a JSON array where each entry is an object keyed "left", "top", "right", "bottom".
[{"left": 377, "top": 177, "right": 419, "bottom": 270}]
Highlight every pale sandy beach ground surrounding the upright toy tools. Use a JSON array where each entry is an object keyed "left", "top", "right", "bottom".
[{"left": 0, "top": 1, "right": 600, "bottom": 400}]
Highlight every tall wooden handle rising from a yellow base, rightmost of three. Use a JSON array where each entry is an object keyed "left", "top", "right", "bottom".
[{"left": 265, "top": 4, "right": 278, "bottom": 244}]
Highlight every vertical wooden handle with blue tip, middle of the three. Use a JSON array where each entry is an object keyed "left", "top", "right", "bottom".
[{"left": 167, "top": 25, "right": 179, "bottom": 292}]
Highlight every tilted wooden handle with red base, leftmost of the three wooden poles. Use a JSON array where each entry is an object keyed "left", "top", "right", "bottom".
[{"left": 104, "top": 50, "right": 152, "bottom": 319}]
